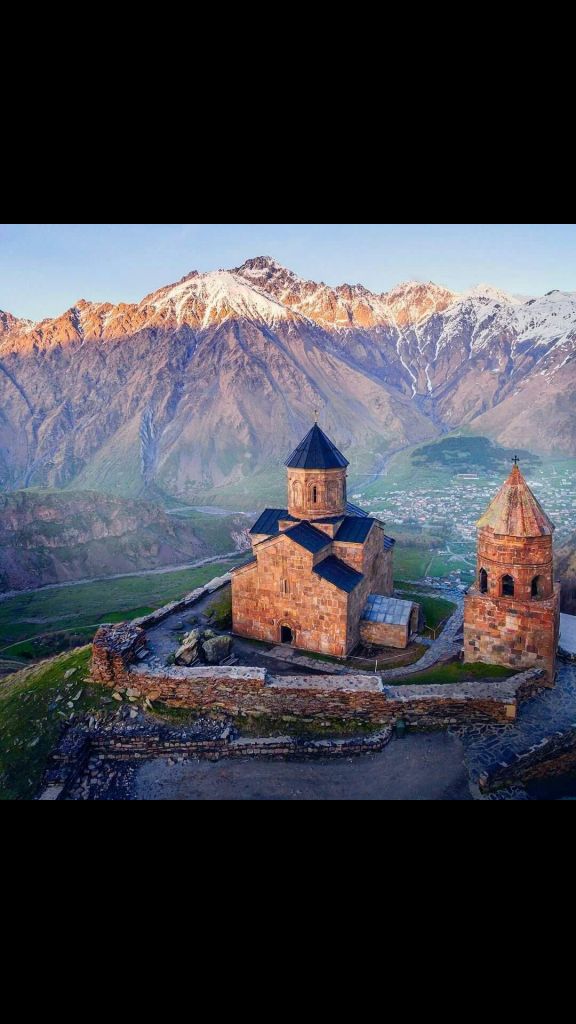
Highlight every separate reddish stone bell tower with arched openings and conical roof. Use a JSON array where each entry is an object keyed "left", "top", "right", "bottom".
[{"left": 464, "top": 466, "right": 560, "bottom": 686}]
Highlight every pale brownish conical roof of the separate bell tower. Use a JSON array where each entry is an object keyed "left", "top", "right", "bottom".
[{"left": 477, "top": 466, "right": 556, "bottom": 537}]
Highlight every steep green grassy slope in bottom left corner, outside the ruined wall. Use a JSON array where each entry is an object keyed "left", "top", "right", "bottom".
[{"left": 0, "top": 647, "right": 108, "bottom": 800}]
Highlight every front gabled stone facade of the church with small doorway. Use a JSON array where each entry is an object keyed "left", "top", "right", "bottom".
[{"left": 232, "top": 538, "right": 348, "bottom": 656}]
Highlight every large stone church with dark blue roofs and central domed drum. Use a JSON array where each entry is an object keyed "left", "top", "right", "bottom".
[{"left": 232, "top": 424, "right": 419, "bottom": 656}]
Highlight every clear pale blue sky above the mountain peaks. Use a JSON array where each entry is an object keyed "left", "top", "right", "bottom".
[{"left": 0, "top": 224, "right": 576, "bottom": 319}]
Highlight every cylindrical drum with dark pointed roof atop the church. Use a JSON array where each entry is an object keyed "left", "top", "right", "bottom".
[{"left": 285, "top": 423, "right": 348, "bottom": 520}]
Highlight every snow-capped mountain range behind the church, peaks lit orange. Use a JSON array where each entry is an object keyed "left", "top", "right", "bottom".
[{"left": 0, "top": 257, "right": 576, "bottom": 496}]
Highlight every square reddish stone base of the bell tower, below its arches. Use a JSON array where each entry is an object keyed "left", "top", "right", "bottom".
[{"left": 464, "top": 586, "right": 560, "bottom": 686}]
